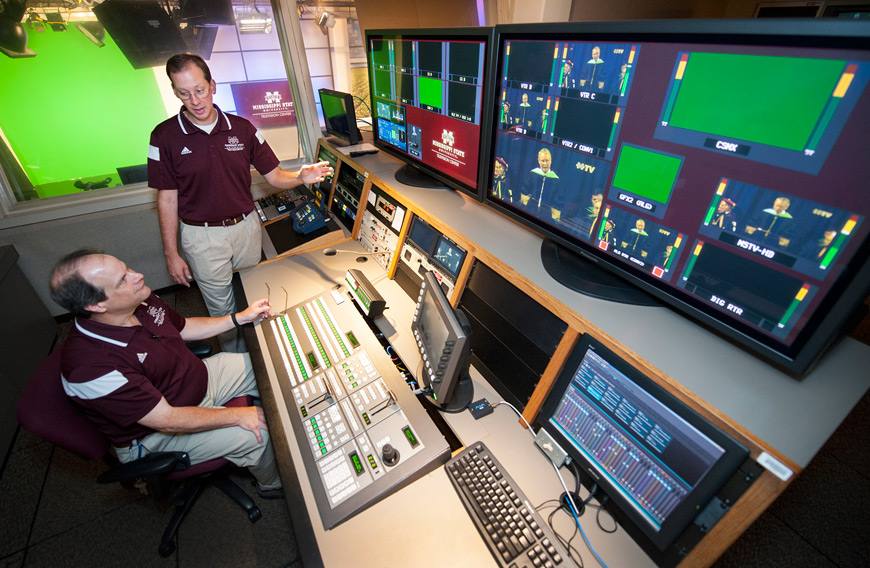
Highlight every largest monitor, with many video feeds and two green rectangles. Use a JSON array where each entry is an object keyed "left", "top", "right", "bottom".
[{"left": 486, "top": 20, "right": 870, "bottom": 374}]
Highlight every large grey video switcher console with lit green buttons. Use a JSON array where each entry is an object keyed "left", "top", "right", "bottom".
[{"left": 264, "top": 288, "right": 450, "bottom": 530}]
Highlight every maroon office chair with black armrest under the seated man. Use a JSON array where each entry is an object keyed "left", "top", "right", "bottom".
[{"left": 16, "top": 346, "right": 262, "bottom": 557}]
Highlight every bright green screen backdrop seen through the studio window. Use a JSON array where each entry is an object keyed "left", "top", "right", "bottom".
[{"left": 0, "top": 24, "right": 166, "bottom": 197}]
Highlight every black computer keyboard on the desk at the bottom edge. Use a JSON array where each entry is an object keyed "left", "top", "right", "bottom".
[{"left": 444, "top": 442, "right": 567, "bottom": 568}]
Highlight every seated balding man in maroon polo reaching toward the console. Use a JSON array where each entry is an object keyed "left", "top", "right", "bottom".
[{"left": 51, "top": 250, "right": 284, "bottom": 499}]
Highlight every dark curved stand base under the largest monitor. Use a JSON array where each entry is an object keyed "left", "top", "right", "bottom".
[{"left": 541, "top": 239, "right": 661, "bottom": 306}]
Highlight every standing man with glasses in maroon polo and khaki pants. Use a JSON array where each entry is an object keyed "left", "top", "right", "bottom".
[{"left": 148, "top": 53, "right": 332, "bottom": 350}]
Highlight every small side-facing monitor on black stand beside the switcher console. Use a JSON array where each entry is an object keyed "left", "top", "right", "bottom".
[{"left": 411, "top": 271, "right": 474, "bottom": 412}]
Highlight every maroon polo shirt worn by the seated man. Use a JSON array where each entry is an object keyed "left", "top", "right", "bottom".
[{"left": 61, "top": 294, "right": 208, "bottom": 447}]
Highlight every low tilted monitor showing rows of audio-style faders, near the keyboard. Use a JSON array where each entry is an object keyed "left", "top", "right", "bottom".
[{"left": 536, "top": 334, "right": 749, "bottom": 550}]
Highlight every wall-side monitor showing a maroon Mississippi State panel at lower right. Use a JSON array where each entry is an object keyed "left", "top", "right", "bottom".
[{"left": 366, "top": 28, "right": 492, "bottom": 197}]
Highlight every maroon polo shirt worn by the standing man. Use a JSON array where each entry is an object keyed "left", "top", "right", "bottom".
[{"left": 148, "top": 105, "right": 279, "bottom": 223}]
